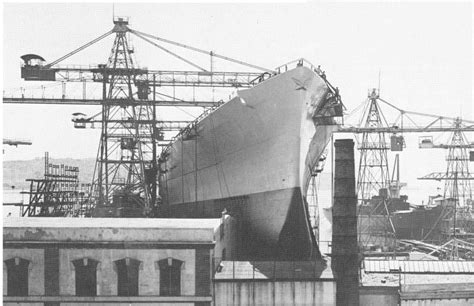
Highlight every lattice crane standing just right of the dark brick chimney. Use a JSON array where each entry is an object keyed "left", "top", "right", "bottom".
[{"left": 337, "top": 89, "right": 474, "bottom": 246}]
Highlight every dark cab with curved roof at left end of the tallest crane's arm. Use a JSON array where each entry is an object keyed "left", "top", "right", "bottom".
[{"left": 21, "top": 54, "right": 56, "bottom": 81}]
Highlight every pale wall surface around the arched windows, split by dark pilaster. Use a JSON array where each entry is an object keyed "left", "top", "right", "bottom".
[{"left": 3, "top": 249, "right": 198, "bottom": 296}]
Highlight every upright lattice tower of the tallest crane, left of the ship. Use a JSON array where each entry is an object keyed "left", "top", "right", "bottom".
[{"left": 92, "top": 18, "right": 157, "bottom": 216}]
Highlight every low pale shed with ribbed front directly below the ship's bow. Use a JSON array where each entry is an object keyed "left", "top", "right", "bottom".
[{"left": 213, "top": 260, "right": 336, "bottom": 306}]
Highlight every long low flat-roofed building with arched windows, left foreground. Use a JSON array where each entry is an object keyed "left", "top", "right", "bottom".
[{"left": 3, "top": 216, "right": 235, "bottom": 306}]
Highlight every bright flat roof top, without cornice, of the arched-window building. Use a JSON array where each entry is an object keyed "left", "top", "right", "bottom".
[{"left": 3, "top": 217, "right": 222, "bottom": 229}]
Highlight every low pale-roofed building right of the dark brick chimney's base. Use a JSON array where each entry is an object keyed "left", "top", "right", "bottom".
[{"left": 359, "top": 259, "right": 474, "bottom": 306}]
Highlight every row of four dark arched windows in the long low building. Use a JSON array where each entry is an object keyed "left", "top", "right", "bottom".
[{"left": 4, "top": 257, "right": 183, "bottom": 296}]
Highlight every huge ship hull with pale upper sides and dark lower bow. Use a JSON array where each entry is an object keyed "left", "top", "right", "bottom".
[{"left": 159, "top": 60, "right": 342, "bottom": 259}]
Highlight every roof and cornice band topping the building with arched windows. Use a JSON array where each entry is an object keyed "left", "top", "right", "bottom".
[{"left": 3, "top": 217, "right": 222, "bottom": 245}]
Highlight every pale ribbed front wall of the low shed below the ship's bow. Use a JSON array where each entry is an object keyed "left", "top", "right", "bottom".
[{"left": 214, "top": 280, "right": 336, "bottom": 306}]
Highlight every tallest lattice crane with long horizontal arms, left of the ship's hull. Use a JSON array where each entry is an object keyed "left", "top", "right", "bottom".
[{"left": 3, "top": 17, "right": 278, "bottom": 216}]
